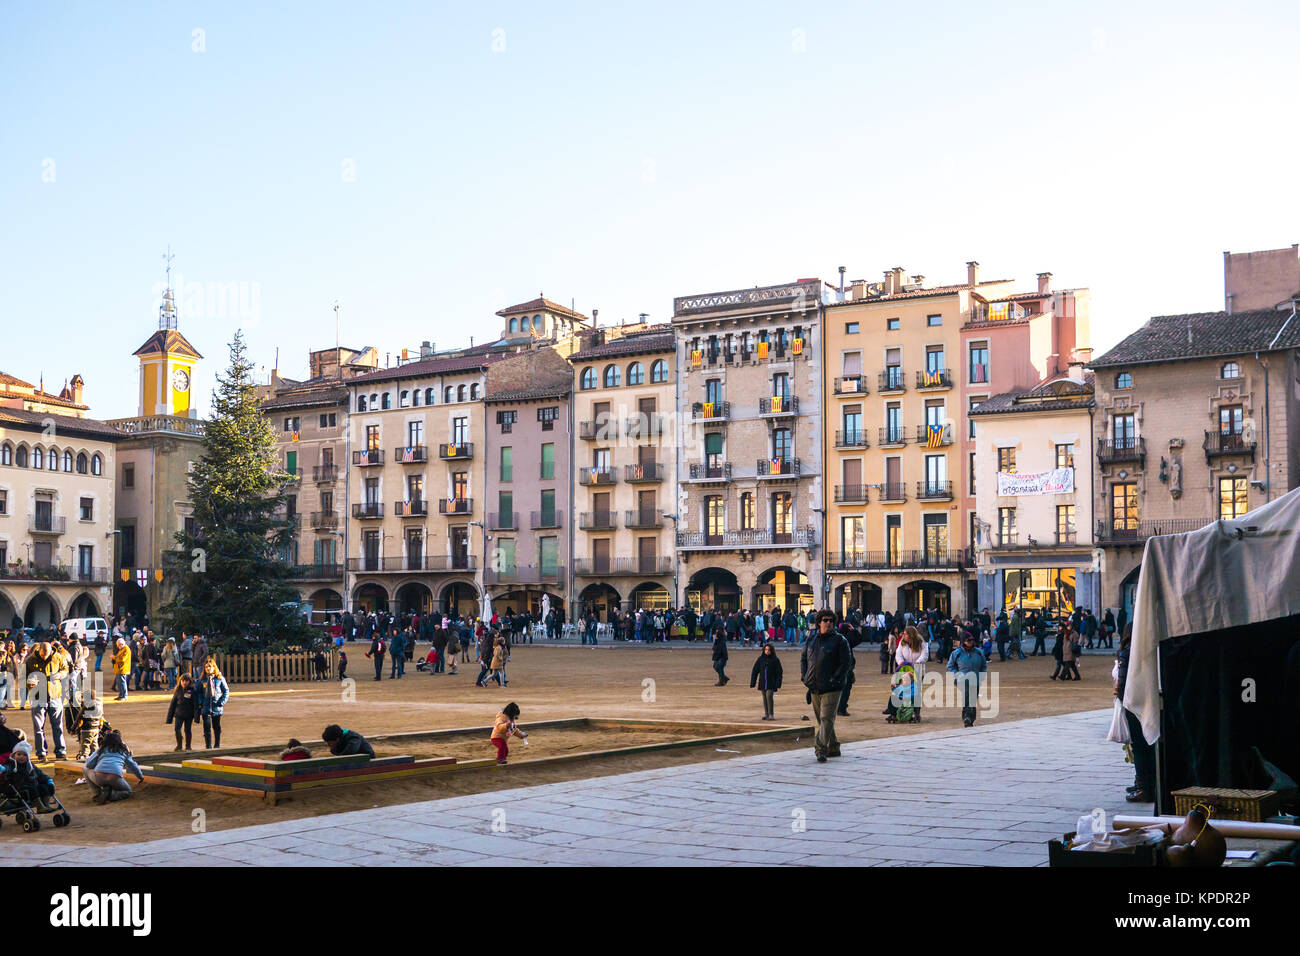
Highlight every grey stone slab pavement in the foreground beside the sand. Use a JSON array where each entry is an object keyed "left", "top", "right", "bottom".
[{"left": 0, "top": 710, "right": 1128, "bottom": 866}]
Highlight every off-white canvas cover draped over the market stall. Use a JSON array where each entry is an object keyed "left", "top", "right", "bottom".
[{"left": 1123, "top": 488, "right": 1300, "bottom": 744}]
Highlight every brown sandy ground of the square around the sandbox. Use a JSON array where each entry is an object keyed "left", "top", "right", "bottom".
[{"left": 0, "top": 645, "right": 1112, "bottom": 844}]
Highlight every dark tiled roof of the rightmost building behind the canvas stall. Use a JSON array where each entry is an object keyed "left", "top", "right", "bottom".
[{"left": 1092, "top": 308, "right": 1300, "bottom": 368}]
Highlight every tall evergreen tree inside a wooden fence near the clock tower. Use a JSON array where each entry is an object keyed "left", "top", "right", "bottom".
[{"left": 161, "top": 330, "right": 311, "bottom": 652}]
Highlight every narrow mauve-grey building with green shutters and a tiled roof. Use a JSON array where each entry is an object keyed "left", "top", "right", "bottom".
[{"left": 482, "top": 347, "right": 573, "bottom": 613}]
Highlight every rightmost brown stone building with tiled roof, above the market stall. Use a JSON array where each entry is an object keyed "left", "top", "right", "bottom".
[{"left": 1092, "top": 302, "right": 1300, "bottom": 619}]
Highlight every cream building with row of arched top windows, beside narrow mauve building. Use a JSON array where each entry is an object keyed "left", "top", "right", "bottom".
[{"left": 569, "top": 325, "right": 677, "bottom": 620}]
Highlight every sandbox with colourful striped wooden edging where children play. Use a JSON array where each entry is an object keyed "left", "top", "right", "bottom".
[{"left": 56, "top": 717, "right": 802, "bottom": 805}]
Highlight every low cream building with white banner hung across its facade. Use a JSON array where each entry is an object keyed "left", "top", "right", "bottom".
[{"left": 970, "top": 363, "right": 1101, "bottom": 617}]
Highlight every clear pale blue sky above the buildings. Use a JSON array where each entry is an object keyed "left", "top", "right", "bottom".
[{"left": 0, "top": 0, "right": 1300, "bottom": 418}]
